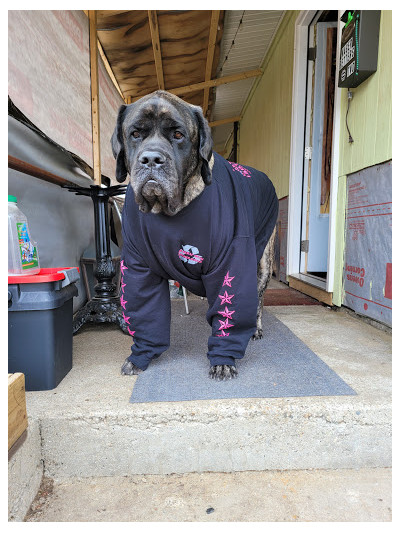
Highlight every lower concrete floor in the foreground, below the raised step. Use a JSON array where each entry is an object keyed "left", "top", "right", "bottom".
[{"left": 26, "top": 469, "right": 392, "bottom": 522}]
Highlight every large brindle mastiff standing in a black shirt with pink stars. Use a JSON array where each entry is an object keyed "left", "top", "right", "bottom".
[{"left": 111, "top": 91, "right": 278, "bottom": 380}]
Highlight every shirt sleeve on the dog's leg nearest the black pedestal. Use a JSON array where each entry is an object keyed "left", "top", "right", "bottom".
[{"left": 121, "top": 227, "right": 171, "bottom": 370}]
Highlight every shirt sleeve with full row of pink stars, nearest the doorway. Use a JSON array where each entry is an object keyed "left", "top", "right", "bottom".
[{"left": 202, "top": 237, "right": 257, "bottom": 366}]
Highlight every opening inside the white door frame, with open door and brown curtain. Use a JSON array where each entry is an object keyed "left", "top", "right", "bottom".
[{"left": 300, "top": 22, "right": 337, "bottom": 279}]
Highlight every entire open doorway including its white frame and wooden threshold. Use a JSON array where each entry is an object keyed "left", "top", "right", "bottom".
[{"left": 287, "top": 11, "right": 340, "bottom": 303}]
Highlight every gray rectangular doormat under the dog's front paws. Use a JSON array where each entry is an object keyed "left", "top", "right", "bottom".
[{"left": 130, "top": 300, "right": 356, "bottom": 403}]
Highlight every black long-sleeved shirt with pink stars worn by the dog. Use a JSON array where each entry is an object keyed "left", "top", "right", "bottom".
[{"left": 121, "top": 153, "right": 278, "bottom": 370}]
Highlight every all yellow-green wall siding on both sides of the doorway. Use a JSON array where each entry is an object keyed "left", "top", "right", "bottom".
[{"left": 239, "top": 11, "right": 392, "bottom": 306}]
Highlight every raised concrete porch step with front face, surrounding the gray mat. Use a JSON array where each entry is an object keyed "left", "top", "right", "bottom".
[{"left": 21, "top": 301, "right": 391, "bottom": 479}]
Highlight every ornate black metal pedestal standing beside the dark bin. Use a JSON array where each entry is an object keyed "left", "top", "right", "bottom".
[{"left": 66, "top": 185, "right": 129, "bottom": 334}]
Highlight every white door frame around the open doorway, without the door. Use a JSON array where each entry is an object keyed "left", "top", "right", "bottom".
[{"left": 287, "top": 10, "right": 343, "bottom": 292}]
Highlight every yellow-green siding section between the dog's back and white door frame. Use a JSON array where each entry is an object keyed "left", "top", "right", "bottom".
[{"left": 239, "top": 11, "right": 299, "bottom": 198}]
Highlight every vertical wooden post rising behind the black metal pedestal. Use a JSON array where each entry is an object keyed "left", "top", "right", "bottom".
[{"left": 89, "top": 10, "right": 101, "bottom": 185}]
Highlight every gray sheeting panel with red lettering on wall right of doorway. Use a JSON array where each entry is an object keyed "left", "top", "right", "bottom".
[{"left": 343, "top": 161, "right": 392, "bottom": 326}]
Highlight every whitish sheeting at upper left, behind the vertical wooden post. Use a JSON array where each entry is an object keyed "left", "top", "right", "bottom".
[{"left": 8, "top": 10, "right": 123, "bottom": 180}]
